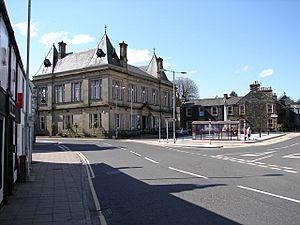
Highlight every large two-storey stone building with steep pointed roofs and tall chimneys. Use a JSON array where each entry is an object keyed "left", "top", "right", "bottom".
[{"left": 33, "top": 33, "right": 172, "bottom": 137}]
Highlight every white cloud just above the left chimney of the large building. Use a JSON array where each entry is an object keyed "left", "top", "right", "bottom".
[{"left": 40, "top": 31, "right": 95, "bottom": 47}]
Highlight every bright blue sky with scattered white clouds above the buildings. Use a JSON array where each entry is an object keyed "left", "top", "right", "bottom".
[{"left": 5, "top": 0, "right": 300, "bottom": 100}]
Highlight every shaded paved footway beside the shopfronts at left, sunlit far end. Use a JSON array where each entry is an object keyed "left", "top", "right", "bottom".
[{"left": 0, "top": 149, "right": 99, "bottom": 225}]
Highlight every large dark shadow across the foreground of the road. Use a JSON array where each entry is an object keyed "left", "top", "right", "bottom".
[{"left": 93, "top": 163, "right": 239, "bottom": 225}]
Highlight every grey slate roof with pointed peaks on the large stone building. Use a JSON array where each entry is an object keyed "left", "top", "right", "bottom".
[{"left": 35, "top": 34, "right": 169, "bottom": 81}]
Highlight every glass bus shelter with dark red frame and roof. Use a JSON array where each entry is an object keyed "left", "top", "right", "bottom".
[{"left": 192, "top": 121, "right": 241, "bottom": 140}]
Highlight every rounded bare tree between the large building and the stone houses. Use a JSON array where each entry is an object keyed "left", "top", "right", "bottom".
[{"left": 175, "top": 77, "right": 199, "bottom": 103}]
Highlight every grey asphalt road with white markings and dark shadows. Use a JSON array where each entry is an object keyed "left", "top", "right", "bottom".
[{"left": 37, "top": 138, "right": 300, "bottom": 225}]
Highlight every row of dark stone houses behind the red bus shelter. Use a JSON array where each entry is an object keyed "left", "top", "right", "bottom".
[{"left": 180, "top": 82, "right": 278, "bottom": 131}]
